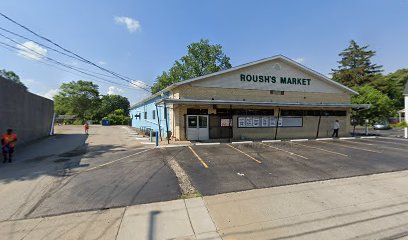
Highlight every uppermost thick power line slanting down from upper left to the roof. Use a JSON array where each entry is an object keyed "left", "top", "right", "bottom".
[{"left": 0, "top": 12, "right": 151, "bottom": 93}]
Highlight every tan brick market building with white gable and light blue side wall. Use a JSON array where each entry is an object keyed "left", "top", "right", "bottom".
[{"left": 131, "top": 55, "right": 368, "bottom": 141}]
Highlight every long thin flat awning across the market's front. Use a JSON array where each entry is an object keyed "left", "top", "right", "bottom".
[{"left": 156, "top": 98, "right": 371, "bottom": 110}]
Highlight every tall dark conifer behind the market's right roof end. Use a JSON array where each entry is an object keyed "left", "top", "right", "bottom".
[{"left": 332, "top": 40, "right": 382, "bottom": 87}]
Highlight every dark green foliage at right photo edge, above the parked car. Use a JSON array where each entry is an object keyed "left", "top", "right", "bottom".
[{"left": 373, "top": 68, "right": 408, "bottom": 110}]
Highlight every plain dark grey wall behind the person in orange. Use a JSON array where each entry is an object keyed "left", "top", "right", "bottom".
[{"left": 0, "top": 77, "right": 54, "bottom": 144}]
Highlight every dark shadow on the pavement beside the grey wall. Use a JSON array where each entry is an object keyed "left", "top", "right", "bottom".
[{"left": 0, "top": 134, "right": 131, "bottom": 183}]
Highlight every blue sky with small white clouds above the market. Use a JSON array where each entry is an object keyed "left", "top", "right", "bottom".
[{"left": 0, "top": 0, "right": 408, "bottom": 103}]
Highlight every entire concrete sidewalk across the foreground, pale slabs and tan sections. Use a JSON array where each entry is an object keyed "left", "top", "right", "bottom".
[{"left": 0, "top": 171, "right": 408, "bottom": 240}]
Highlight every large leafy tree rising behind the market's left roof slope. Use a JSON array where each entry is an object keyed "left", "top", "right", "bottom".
[{"left": 152, "top": 39, "right": 231, "bottom": 93}]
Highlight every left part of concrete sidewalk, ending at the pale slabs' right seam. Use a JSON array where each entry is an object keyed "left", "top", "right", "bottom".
[{"left": 0, "top": 198, "right": 221, "bottom": 240}]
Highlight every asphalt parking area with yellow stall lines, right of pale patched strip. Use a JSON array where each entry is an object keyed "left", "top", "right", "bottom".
[{"left": 171, "top": 138, "right": 408, "bottom": 195}]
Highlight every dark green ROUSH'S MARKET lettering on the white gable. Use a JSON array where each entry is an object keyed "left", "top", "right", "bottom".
[{"left": 240, "top": 74, "right": 311, "bottom": 86}]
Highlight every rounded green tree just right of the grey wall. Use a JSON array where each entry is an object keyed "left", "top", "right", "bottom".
[{"left": 54, "top": 80, "right": 100, "bottom": 120}]
